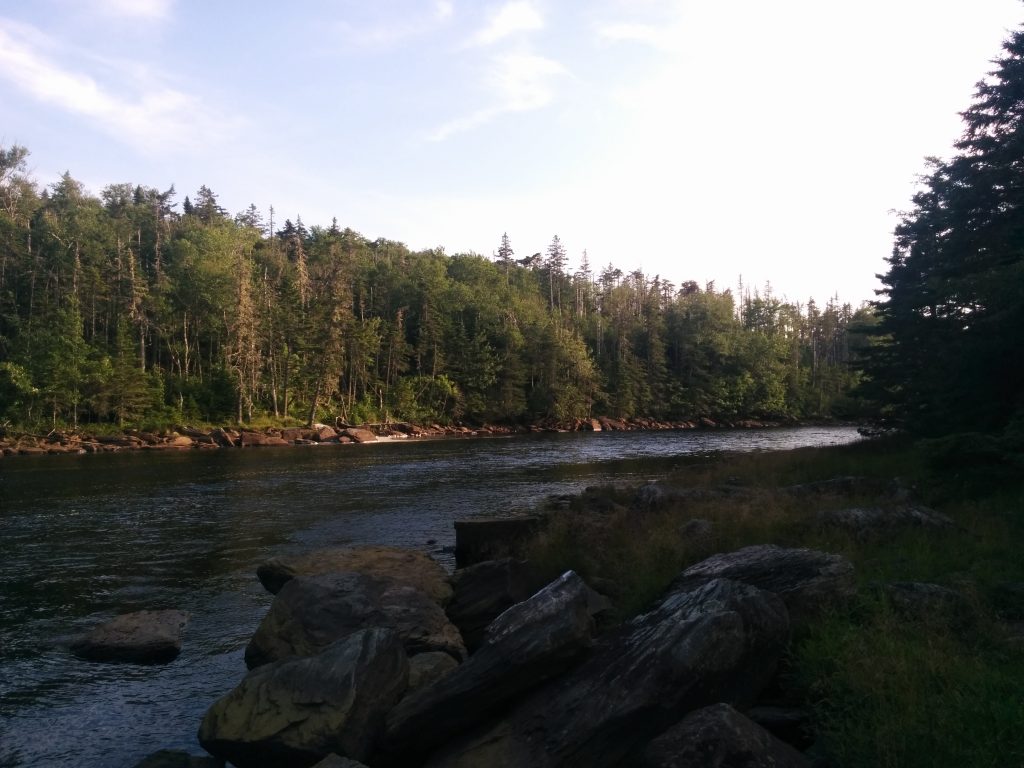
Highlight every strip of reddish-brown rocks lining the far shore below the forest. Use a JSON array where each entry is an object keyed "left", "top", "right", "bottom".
[{"left": 0, "top": 417, "right": 780, "bottom": 456}]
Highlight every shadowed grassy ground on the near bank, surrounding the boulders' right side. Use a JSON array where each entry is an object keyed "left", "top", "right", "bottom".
[{"left": 529, "top": 439, "right": 1024, "bottom": 768}]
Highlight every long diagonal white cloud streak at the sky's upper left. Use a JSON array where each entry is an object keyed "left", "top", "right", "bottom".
[{"left": 0, "top": 19, "right": 234, "bottom": 151}]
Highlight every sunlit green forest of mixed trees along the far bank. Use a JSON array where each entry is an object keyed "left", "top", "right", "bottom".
[{"left": 0, "top": 145, "right": 873, "bottom": 434}]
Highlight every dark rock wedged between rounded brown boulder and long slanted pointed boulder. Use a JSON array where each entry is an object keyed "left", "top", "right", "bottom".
[{"left": 445, "top": 557, "right": 544, "bottom": 651}]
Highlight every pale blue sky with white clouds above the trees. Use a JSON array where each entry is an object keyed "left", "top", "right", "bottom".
[{"left": 0, "top": 0, "right": 1024, "bottom": 305}]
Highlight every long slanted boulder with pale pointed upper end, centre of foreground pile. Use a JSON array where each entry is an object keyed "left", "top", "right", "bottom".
[{"left": 387, "top": 570, "right": 593, "bottom": 764}]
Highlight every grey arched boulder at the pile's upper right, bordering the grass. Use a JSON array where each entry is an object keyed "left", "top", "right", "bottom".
[{"left": 673, "top": 545, "right": 856, "bottom": 626}]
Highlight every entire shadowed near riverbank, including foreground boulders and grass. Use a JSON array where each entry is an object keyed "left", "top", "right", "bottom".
[{"left": 123, "top": 440, "right": 1024, "bottom": 768}]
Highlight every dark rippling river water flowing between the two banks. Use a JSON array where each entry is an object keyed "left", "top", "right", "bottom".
[{"left": 0, "top": 427, "right": 858, "bottom": 768}]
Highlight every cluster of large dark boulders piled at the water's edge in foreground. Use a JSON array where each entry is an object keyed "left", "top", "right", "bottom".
[{"left": 101, "top": 546, "right": 854, "bottom": 768}]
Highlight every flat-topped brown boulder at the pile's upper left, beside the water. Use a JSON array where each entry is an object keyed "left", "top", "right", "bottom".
[{"left": 256, "top": 547, "right": 452, "bottom": 605}]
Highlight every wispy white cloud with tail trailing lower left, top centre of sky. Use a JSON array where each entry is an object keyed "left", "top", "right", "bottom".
[{"left": 430, "top": 53, "right": 568, "bottom": 141}]
